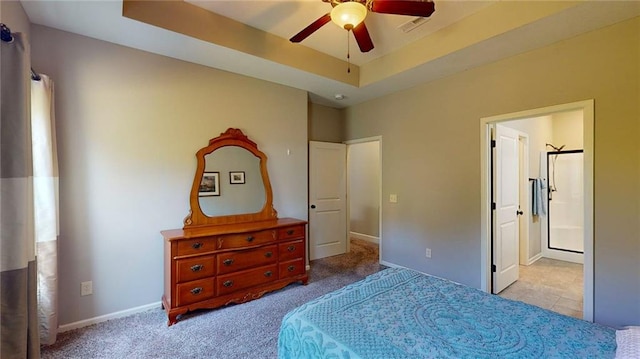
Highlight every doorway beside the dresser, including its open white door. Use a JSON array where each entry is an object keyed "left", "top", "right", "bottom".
[{"left": 309, "top": 136, "right": 383, "bottom": 263}]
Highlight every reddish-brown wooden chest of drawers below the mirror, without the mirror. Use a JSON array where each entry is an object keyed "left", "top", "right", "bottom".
[{"left": 161, "top": 218, "right": 308, "bottom": 325}]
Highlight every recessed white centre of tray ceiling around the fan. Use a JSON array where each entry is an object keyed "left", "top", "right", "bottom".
[{"left": 185, "top": 0, "right": 495, "bottom": 65}]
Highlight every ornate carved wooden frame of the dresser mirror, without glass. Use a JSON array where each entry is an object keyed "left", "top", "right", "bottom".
[{"left": 183, "top": 128, "right": 278, "bottom": 229}]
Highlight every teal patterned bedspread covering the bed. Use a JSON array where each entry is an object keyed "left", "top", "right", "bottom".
[{"left": 278, "top": 268, "right": 616, "bottom": 359}]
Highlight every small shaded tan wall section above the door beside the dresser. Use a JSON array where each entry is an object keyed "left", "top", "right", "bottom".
[{"left": 309, "top": 103, "right": 344, "bottom": 143}]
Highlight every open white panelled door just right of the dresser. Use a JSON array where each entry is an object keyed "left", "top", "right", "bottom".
[{"left": 309, "top": 141, "right": 347, "bottom": 260}]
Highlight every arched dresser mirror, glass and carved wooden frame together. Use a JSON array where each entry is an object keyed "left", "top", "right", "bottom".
[{"left": 184, "top": 128, "right": 277, "bottom": 229}]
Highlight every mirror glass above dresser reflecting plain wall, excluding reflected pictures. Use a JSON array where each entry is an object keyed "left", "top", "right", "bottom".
[{"left": 198, "top": 146, "right": 266, "bottom": 217}]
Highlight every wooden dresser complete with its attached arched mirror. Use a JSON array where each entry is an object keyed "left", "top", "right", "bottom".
[{"left": 160, "top": 128, "right": 308, "bottom": 325}]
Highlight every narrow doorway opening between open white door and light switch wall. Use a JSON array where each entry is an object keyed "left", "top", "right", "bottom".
[{"left": 345, "top": 136, "right": 382, "bottom": 259}]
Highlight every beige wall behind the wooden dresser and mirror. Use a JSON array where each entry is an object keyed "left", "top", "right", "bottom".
[{"left": 31, "top": 25, "right": 307, "bottom": 324}]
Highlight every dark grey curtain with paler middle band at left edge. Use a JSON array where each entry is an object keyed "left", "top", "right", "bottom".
[{"left": 0, "top": 33, "right": 40, "bottom": 359}]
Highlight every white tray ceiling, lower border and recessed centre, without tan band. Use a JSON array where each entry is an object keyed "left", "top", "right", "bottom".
[{"left": 21, "top": 0, "right": 640, "bottom": 108}]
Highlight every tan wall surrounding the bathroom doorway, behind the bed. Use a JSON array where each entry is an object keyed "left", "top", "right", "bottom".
[{"left": 346, "top": 18, "right": 640, "bottom": 325}]
